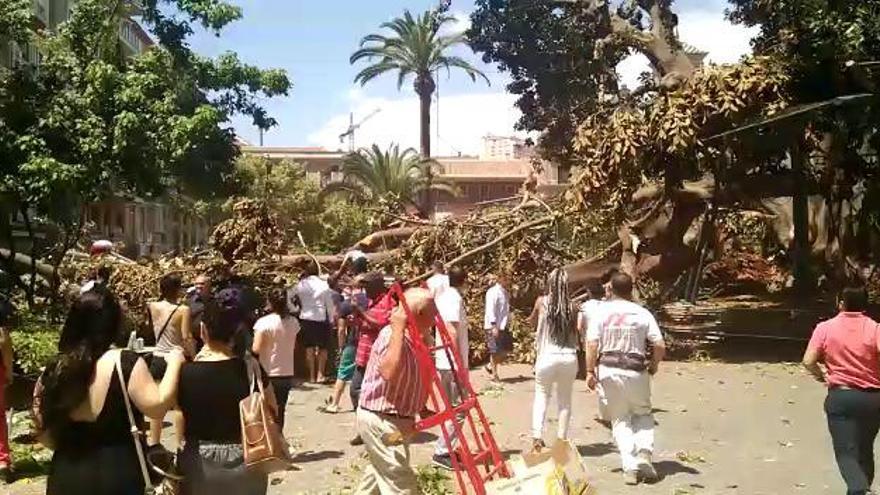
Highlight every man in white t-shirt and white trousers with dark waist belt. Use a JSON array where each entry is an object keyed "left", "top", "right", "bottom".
[{"left": 587, "top": 273, "right": 666, "bottom": 485}]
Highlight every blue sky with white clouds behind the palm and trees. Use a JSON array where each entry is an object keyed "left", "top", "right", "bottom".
[{"left": 191, "top": 0, "right": 753, "bottom": 155}]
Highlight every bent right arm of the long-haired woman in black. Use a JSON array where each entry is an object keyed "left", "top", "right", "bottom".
[{"left": 128, "top": 349, "right": 185, "bottom": 418}]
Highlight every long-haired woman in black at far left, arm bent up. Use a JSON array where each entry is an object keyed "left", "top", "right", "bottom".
[{"left": 36, "top": 287, "right": 183, "bottom": 495}]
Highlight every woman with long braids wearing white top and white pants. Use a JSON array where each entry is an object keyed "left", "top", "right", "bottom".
[{"left": 530, "top": 268, "right": 579, "bottom": 450}]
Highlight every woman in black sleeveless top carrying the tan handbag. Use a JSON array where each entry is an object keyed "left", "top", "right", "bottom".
[{"left": 177, "top": 296, "right": 274, "bottom": 495}]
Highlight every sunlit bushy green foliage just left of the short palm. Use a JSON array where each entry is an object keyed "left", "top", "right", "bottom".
[{"left": 237, "top": 155, "right": 376, "bottom": 253}]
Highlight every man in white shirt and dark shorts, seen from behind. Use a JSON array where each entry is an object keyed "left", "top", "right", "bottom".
[{"left": 291, "top": 261, "right": 336, "bottom": 383}]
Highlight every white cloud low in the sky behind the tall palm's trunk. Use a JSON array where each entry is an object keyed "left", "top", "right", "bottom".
[{"left": 307, "top": 92, "right": 525, "bottom": 155}]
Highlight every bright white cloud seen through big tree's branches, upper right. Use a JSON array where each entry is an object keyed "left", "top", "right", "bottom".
[{"left": 617, "top": 10, "right": 757, "bottom": 88}]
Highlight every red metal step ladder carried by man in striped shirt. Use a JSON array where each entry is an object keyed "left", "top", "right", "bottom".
[{"left": 391, "top": 284, "right": 510, "bottom": 495}]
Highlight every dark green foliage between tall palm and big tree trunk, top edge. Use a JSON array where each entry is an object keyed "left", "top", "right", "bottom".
[{"left": 467, "top": 0, "right": 625, "bottom": 166}]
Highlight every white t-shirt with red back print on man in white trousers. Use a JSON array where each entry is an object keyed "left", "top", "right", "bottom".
[{"left": 587, "top": 299, "right": 663, "bottom": 356}]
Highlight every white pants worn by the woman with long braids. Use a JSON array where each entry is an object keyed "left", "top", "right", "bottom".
[{"left": 532, "top": 353, "right": 577, "bottom": 440}]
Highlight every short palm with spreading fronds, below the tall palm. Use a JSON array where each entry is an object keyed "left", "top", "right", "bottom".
[{"left": 323, "top": 144, "right": 457, "bottom": 213}]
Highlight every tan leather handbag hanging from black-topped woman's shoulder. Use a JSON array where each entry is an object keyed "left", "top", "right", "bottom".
[{"left": 238, "top": 358, "right": 292, "bottom": 474}]
